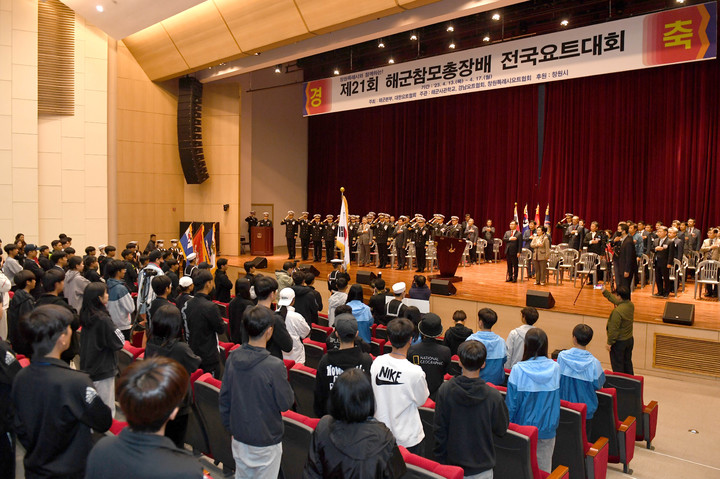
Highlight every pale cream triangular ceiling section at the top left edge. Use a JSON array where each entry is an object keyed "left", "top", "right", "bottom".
[{"left": 61, "top": 0, "right": 203, "bottom": 40}]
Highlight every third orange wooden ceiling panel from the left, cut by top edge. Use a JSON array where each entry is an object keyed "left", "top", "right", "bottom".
[{"left": 213, "top": 0, "right": 312, "bottom": 53}]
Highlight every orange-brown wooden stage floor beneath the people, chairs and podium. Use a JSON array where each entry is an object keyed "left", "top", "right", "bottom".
[{"left": 227, "top": 249, "right": 720, "bottom": 331}]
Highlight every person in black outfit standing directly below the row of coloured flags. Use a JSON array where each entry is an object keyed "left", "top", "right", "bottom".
[{"left": 182, "top": 270, "right": 225, "bottom": 379}]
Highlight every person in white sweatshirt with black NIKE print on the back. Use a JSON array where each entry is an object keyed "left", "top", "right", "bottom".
[{"left": 370, "top": 318, "right": 430, "bottom": 453}]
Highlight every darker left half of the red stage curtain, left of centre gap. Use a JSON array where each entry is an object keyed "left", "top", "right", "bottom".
[{"left": 308, "top": 86, "right": 538, "bottom": 229}]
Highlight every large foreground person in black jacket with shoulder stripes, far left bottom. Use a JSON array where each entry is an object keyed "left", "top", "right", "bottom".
[{"left": 11, "top": 306, "right": 112, "bottom": 479}]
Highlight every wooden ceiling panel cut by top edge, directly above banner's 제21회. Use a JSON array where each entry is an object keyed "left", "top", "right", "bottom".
[{"left": 295, "top": 0, "right": 402, "bottom": 33}]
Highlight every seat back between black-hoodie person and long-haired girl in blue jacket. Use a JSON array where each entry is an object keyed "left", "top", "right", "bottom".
[{"left": 493, "top": 423, "right": 540, "bottom": 479}]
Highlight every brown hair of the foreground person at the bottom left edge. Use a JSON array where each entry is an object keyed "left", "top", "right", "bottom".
[{"left": 116, "top": 356, "right": 190, "bottom": 432}]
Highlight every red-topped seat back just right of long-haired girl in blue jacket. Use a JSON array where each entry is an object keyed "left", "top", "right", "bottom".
[{"left": 553, "top": 401, "right": 587, "bottom": 479}]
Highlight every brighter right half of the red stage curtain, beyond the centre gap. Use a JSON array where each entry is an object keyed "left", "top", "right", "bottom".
[{"left": 539, "top": 60, "right": 720, "bottom": 239}]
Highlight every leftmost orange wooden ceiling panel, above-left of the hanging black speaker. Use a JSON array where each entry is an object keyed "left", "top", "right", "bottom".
[{"left": 123, "top": 23, "right": 189, "bottom": 80}]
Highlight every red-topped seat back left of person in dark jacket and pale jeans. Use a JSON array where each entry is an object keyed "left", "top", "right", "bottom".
[{"left": 195, "top": 374, "right": 235, "bottom": 470}]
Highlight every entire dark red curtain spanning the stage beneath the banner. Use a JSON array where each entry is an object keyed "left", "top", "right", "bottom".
[{"left": 308, "top": 60, "right": 720, "bottom": 236}]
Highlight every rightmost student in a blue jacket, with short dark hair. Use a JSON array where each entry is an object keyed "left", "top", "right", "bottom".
[{"left": 558, "top": 324, "right": 605, "bottom": 437}]
